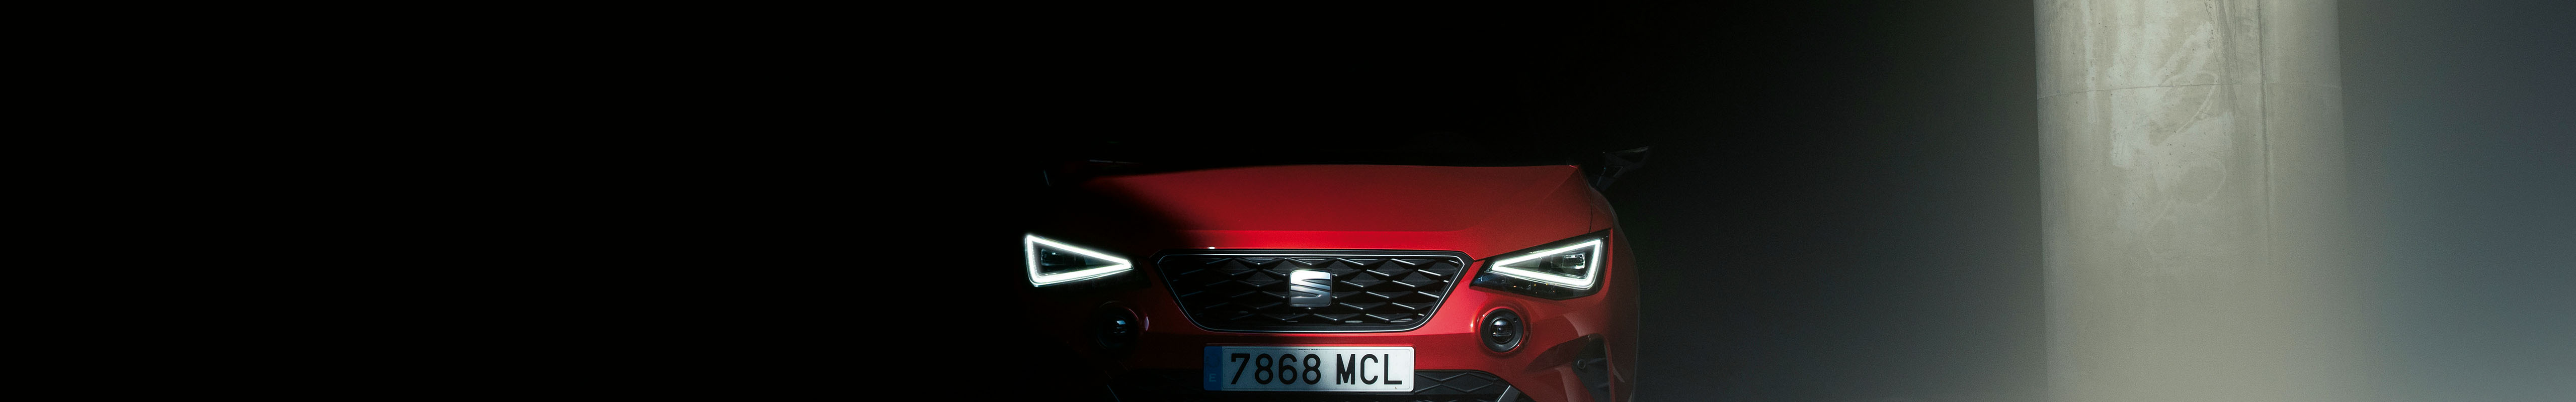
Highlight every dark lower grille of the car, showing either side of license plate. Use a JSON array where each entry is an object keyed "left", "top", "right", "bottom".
[{"left": 1110, "top": 371, "right": 1530, "bottom": 402}]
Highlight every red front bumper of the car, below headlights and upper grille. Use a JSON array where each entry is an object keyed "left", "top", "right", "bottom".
[{"left": 1025, "top": 240, "right": 1636, "bottom": 402}]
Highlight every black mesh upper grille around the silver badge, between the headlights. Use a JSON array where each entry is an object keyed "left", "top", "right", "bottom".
[{"left": 1154, "top": 250, "right": 1466, "bottom": 333}]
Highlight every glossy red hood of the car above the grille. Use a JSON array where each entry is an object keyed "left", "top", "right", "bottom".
[{"left": 1061, "top": 165, "right": 1610, "bottom": 258}]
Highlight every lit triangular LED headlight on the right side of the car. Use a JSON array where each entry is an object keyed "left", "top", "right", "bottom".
[{"left": 1476, "top": 232, "right": 1607, "bottom": 299}]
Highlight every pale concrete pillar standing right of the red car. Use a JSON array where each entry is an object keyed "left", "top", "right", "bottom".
[{"left": 2038, "top": 0, "right": 2367, "bottom": 402}]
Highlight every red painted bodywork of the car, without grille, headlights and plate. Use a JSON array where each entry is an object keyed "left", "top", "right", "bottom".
[{"left": 1023, "top": 165, "right": 1638, "bottom": 402}]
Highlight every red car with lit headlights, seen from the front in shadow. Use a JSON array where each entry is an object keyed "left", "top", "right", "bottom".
[{"left": 1020, "top": 153, "right": 1641, "bottom": 402}]
